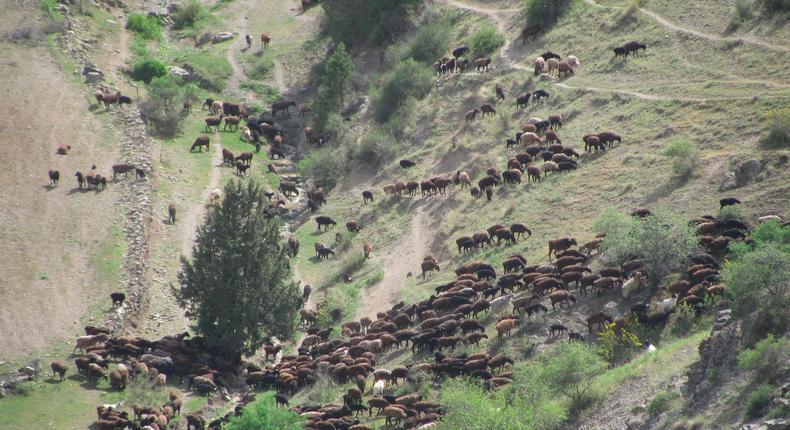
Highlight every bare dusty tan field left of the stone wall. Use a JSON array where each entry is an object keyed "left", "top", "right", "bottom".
[{"left": 0, "top": 9, "right": 115, "bottom": 361}]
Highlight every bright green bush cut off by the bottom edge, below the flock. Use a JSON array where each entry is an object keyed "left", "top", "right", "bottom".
[{"left": 229, "top": 391, "right": 303, "bottom": 430}]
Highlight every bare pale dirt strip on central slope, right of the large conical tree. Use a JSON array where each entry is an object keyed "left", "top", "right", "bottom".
[{"left": 354, "top": 207, "right": 433, "bottom": 320}]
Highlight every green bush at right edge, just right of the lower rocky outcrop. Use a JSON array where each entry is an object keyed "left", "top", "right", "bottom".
[{"left": 738, "top": 335, "right": 790, "bottom": 382}]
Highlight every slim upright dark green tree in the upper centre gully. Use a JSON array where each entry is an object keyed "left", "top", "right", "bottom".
[{"left": 315, "top": 42, "right": 354, "bottom": 129}]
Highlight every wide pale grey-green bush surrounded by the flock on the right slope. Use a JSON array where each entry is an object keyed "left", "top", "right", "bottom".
[{"left": 594, "top": 208, "right": 697, "bottom": 285}]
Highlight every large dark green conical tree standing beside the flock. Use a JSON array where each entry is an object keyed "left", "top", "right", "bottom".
[{"left": 176, "top": 180, "right": 301, "bottom": 358}]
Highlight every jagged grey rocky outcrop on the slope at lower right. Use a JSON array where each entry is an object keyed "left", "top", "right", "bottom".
[{"left": 685, "top": 309, "right": 741, "bottom": 401}]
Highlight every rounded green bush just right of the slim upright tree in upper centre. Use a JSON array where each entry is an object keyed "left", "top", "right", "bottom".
[{"left": 372, "top": 58, "right": 433, "bottom": 122}]
